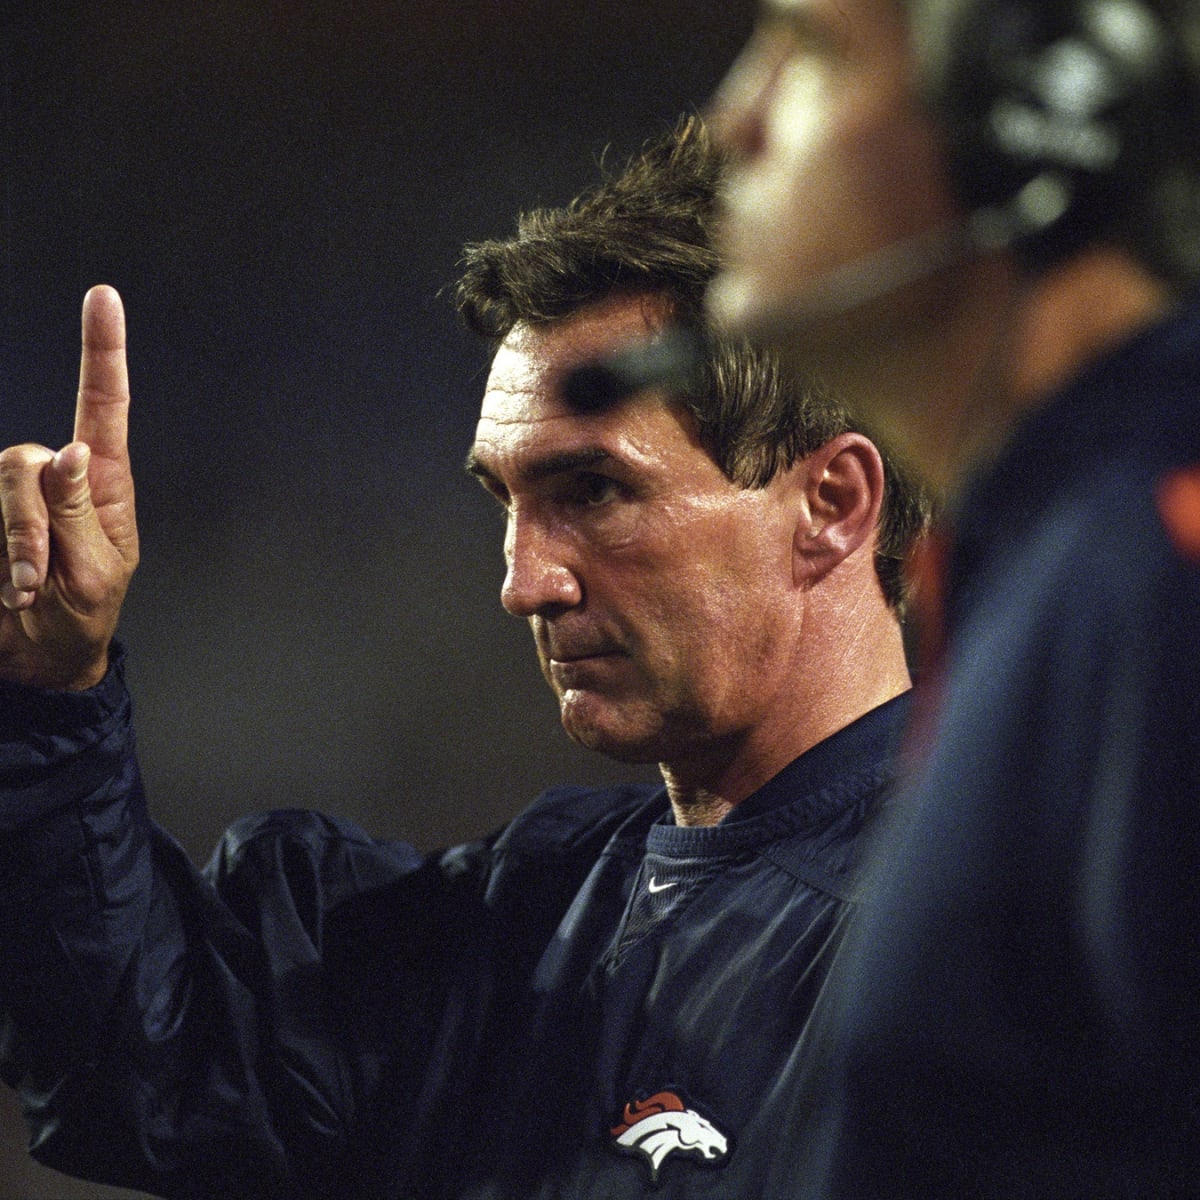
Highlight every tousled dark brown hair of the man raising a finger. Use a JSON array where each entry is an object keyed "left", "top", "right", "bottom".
[{"left": 455, "top": 116, "right": 930, "bottom": 611}]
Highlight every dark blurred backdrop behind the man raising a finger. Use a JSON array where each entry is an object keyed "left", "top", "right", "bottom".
[{"left": 0, "top": 0, "right": 752, "bottom": 1200}]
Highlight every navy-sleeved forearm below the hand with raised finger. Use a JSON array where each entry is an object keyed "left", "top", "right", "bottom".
[{"left": 0, "top": 653, "right": 296, "bottom": 1195}]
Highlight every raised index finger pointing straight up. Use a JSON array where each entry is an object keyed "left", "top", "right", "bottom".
[{"left": 74, "top": 284, "right": 130, "bottom": 458}]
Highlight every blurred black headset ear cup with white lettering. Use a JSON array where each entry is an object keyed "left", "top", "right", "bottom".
[{"left": 926, "top": 0, "right": 1171, "bottom": 260}]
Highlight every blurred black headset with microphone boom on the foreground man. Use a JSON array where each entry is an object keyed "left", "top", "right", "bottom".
[{"left": 566, "top": 0, "right": 1200, "bottom": 408}]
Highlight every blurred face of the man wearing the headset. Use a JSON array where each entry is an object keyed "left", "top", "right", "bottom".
[{"left": 710, "top": 0, "right": 955, "bottom": 341}]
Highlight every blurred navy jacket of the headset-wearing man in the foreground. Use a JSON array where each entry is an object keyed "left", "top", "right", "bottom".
[{"left": 797, "top": 307, "right": 1200, "bottom": 1200}]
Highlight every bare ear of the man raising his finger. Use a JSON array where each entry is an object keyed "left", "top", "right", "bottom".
[{"left": 793, "top": 433, "right": 883, "bottom": 581}]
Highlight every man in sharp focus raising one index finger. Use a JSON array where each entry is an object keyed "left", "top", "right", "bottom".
[{"left": 0, "top": 122, "right": 923, "bottom": 1200}]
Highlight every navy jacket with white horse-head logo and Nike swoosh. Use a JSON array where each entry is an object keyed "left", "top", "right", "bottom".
[{"left": 0, "top": 662, "right": 905, "bottom": 1200}]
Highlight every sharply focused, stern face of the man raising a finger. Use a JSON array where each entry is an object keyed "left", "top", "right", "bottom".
[{"left": 470, "top": 298, "right": 797, "bottom": 762}]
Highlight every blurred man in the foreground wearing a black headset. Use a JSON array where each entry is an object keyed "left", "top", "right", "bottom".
[{"left": 710, "top": 0, "right": 1200, "bottom": 1200}]
